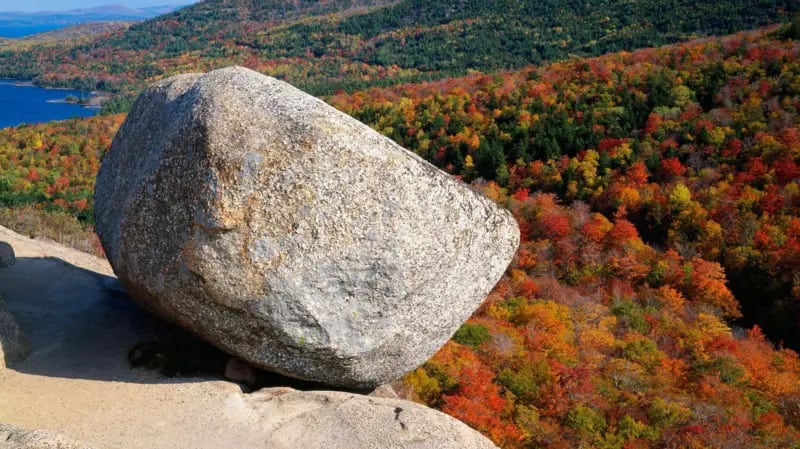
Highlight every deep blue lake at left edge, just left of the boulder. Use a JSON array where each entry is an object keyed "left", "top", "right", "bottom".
[{"left": 0, "top": 80, "right": 98, "bottom": 128}]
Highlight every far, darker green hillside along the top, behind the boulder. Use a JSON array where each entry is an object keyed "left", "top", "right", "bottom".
[{"left": 0, "top": 0, "right": 800, "bottom": 100}]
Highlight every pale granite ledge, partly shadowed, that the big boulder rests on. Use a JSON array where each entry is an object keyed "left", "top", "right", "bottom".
[{"left": 0, "top": 227, "right": 494, "bottom": 449}]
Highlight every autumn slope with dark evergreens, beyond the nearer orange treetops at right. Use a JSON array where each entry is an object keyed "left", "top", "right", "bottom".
[{"left": 331, "top": 25, "right": 800, "bottom": 347}]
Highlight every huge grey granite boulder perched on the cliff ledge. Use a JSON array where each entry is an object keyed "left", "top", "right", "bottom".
[{"left": 95, "top": 67, "right": 519, "bottom": 388}]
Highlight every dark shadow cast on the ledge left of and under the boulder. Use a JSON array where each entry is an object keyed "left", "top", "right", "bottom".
[{"left": 0, "top": 257, "right": 370, "bottom": 392}]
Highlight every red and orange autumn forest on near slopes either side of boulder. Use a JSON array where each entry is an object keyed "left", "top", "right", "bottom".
[{"left": 0, "top": 7, "right": 800, "bottom": 449}]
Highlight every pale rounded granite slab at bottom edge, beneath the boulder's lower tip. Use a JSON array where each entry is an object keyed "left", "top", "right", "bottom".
[{"left": 245, "top": 388, "right": 496, "bottom": 449}]
